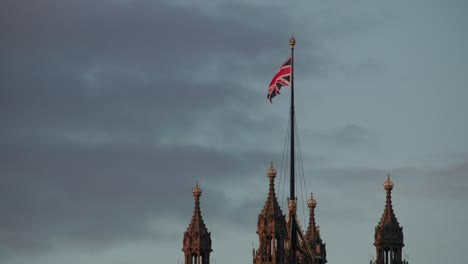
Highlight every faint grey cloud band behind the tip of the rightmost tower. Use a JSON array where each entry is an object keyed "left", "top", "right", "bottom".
[{"left": 306, "top": 162, "right": 468, "bottom": 205}]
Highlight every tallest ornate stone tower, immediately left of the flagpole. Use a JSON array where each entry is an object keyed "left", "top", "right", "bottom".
[{"left": 253, "top": 163, "right": 287, "bottom": 264}]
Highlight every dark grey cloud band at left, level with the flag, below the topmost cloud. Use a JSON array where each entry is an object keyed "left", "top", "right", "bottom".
[{"left": 0, "top": 63, "right": 260, "bottom": 140}]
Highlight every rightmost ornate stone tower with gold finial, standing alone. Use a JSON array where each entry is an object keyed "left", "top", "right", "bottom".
[{"left": 371, "top": 175, "right": 407, "bottom": 264}]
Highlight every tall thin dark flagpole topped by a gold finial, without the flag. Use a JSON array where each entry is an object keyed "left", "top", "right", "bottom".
[{"left": 288, "top": 36, "right": 297, "bottom": 264}]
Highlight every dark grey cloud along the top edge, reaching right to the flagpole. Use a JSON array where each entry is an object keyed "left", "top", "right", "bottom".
[{"left": 1, "top": 1, "right": 316, "bottom": 80}]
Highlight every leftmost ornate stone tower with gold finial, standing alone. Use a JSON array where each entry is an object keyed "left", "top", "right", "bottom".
[{"left": 182, "top": 182, "right": 213, "bottom": 264}]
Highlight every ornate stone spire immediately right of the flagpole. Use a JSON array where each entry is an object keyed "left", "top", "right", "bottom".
[{"left": 304, "top": 193, "right": 327, "bottom": 264}]
